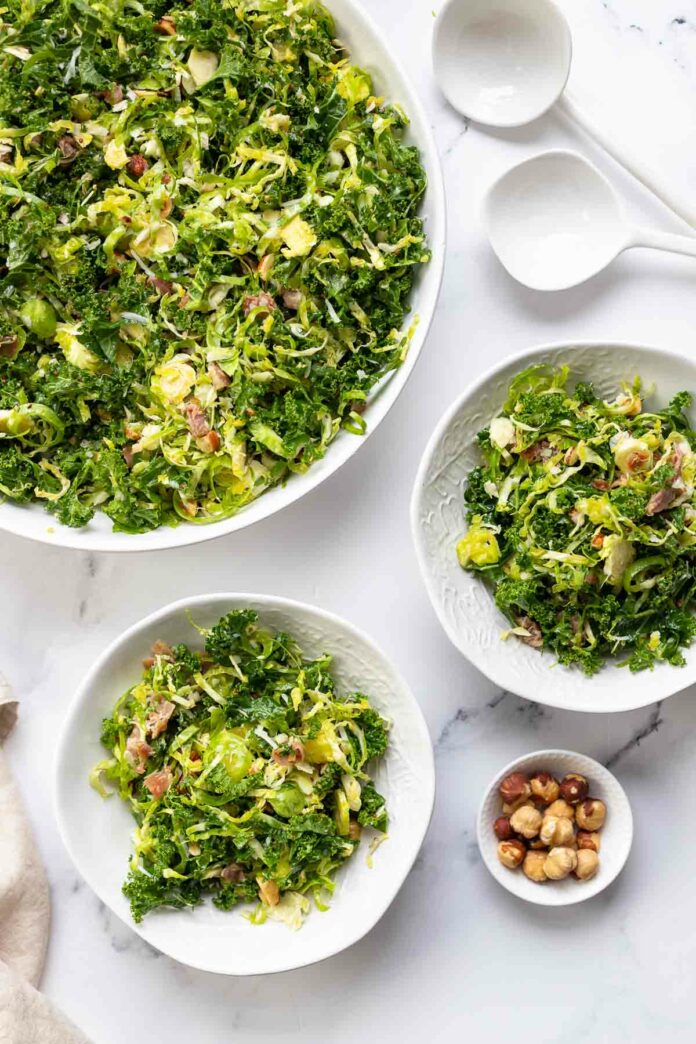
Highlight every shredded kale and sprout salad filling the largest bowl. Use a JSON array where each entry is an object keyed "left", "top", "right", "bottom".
[{"left": 0, "top": 0, "right": 429, "bottom": 532}]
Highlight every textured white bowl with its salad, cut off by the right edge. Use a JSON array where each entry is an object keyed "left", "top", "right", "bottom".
[{"left": 411, "top": 341, "right": 696, "bottom": 712}]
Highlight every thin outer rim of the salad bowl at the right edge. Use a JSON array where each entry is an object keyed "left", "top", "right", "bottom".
[{"left": 410, "top": 337, "right": 696, "bottom": 714}]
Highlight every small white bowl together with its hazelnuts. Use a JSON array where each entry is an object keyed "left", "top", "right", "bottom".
[{"left": 478, "top": 751, "right": 633, "bottom": 906}]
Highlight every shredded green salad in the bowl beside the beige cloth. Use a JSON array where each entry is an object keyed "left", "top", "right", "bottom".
[{"left": 92, "top": 610, "right": 388, "bottom": 927}]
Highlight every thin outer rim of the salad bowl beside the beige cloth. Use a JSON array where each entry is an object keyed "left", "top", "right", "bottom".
[{"left": 52, "top": 591, "right": 436, "bottom": 976}]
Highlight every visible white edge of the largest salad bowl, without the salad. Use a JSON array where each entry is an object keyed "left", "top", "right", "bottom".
[{"left": 0, "top": 0, "right": 446, "bottom": 551}]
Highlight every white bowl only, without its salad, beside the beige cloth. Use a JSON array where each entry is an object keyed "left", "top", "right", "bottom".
[{"left": 55, "top": 594, "right": 435, "bottom": 975}]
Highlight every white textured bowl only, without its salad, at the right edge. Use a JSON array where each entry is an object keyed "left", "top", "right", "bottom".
[{"left": 411, "top": 341, "right": 696, "bottom": 712}]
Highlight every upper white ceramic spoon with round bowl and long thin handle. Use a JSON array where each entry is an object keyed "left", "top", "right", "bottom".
[{"left": 433, "top": 0, "right": 696, "bottom": 226}]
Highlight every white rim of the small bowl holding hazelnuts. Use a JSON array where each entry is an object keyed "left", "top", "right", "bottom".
[{"left": 476, "top": 748, "right": 633, "bottom": 907}]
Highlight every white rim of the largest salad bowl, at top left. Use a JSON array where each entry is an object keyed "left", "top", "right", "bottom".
[{"left": 0, "top": 0, "right": 447, "bottom": 554}]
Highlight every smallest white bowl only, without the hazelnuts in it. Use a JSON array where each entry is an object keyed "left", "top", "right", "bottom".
[{"left": 477, "top": 751, "right": 633, "bottom": 906}]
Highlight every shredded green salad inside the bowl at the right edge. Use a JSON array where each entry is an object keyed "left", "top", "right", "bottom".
[{"left": 457, "top": 365, "right": 696, "bottom": 674}]
